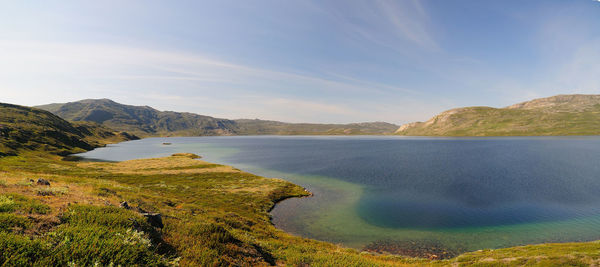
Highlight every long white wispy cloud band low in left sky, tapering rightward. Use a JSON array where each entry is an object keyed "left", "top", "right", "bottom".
[{"left": 0, "top": 41, "right": 412, "bottom": 93}]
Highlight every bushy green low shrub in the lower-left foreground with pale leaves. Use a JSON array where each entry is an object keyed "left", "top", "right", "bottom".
[{"left": 42, "top": 205, "right": 167, "bottom": 266}]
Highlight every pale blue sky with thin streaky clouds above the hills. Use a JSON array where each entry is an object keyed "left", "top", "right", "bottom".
[{"left": 0, "top": 0, "right": 600, "bottom": 124}]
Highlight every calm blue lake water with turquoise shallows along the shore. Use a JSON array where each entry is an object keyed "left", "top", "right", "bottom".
[{"left": 76, "top": 136, "right": 600, "bottom": 254}]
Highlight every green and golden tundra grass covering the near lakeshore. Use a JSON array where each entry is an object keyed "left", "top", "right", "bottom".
[{"left": 0, "top": 153, "right": 600, "bottom": 266}]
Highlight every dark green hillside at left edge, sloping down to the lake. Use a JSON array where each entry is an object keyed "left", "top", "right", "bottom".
[{"left": 0, "top": 103, "right": 135, "bottom": 156}]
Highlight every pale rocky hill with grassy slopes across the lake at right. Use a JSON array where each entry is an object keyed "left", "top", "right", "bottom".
[{"left": 396, "top": 95, "right": 600, "bottom": 136}]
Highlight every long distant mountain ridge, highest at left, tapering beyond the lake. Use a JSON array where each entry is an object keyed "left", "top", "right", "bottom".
[{"left": 37, "top": 99, "right": 398, "bottom": 136}]
